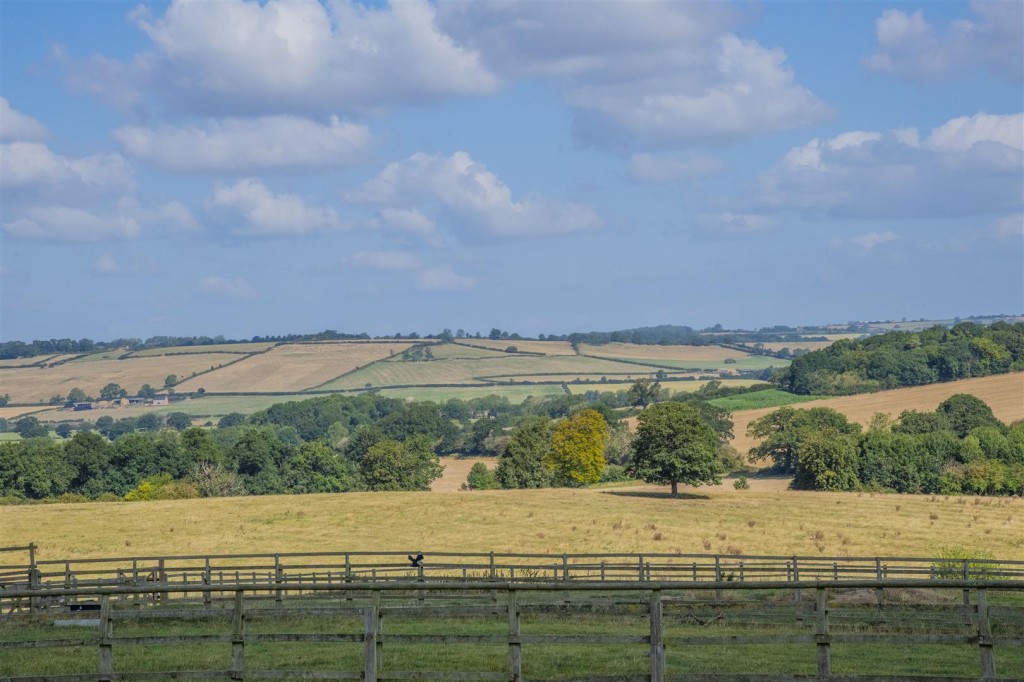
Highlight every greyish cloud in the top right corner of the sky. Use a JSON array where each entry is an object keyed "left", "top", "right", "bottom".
[{"left": 864, "top": 0, "right": 1024, "bottom": 82}]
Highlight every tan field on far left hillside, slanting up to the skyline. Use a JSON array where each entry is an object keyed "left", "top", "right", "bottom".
[{"left": 178, "top": 343, "right": 412, "bottom": 393}]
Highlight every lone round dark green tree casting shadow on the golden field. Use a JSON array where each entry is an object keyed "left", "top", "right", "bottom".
[{"left": 626, "top": 402, "right": 722, "bottom": 497}]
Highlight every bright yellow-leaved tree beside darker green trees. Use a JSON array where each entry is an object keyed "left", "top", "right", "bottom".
[{"left": 544, "top": 410, "right": 608, "bottom": 487}]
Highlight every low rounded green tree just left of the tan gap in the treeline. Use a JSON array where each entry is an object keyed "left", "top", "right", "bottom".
[{"left": 359, "top": 436, "right": 443, "bottom": 491}]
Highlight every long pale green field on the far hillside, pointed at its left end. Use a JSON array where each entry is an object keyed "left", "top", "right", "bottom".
[{"left": 323, "top": 353, "right": 656, "bottom": 389}]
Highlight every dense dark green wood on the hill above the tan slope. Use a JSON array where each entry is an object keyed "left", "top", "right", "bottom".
[{"left": 776, "top": 322, "right": 1024, "bottom": 395}]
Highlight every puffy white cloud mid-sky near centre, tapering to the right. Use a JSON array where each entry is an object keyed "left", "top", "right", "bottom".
[{"left": 348, "top": 152, "right": 602, "bottom": 238}]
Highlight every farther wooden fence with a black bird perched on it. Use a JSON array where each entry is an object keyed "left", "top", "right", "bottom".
[{"left": 0, "top": 545, "right": 1024, "bottom": 609}]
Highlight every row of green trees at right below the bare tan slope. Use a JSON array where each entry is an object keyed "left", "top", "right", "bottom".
[{"left": 746, "top": 393, "right": 1024, "bottom": 496}]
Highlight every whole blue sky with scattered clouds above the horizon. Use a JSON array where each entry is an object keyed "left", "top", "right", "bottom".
[{"left": 0, "top": 0, "right": 1024, "bottom": 341}]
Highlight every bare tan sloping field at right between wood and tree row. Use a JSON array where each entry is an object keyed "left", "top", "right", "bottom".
[{"left": 732, "top": 373, "right": 1024, "bottom": 453}]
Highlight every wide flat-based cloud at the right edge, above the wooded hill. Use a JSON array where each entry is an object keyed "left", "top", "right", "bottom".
[{"left": 753, "top": 114, "right": 1024, "bottom": 219}]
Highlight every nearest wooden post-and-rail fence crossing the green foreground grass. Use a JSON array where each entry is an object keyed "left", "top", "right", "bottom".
[{"left": 0, "top": 579, "right": 1024, "bottom": 682}]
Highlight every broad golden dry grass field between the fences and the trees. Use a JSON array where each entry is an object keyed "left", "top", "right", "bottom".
[{"left": 2, "top": 485, "right": 1024, "bottom": 559}]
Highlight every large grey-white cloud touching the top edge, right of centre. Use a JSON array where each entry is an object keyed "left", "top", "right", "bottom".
[{"left": 438, "top": 0, "right": 831, "bottom": 147}]
